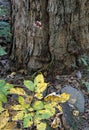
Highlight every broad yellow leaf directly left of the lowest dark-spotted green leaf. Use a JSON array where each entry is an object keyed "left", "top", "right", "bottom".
[{"left": 12, "top": 111, "right": 24, "bottom": 121}]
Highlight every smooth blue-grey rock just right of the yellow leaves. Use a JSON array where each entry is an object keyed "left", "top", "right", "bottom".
[{"left": 61, "top": 85, "right": 85, "bottom": 112}]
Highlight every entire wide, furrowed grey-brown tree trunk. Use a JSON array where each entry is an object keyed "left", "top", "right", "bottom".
[{"left": 11, "top": 0, "right": 89, "bottom": 72}]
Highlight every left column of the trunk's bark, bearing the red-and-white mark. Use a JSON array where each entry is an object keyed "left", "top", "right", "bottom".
[{"left": 12, "top": 0, "right": 50, "bottom": 68}]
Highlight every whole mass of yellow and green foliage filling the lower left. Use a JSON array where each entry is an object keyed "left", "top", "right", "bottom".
[{"left": 0, "top": 74, "right": 70, "bottom": 130}]
